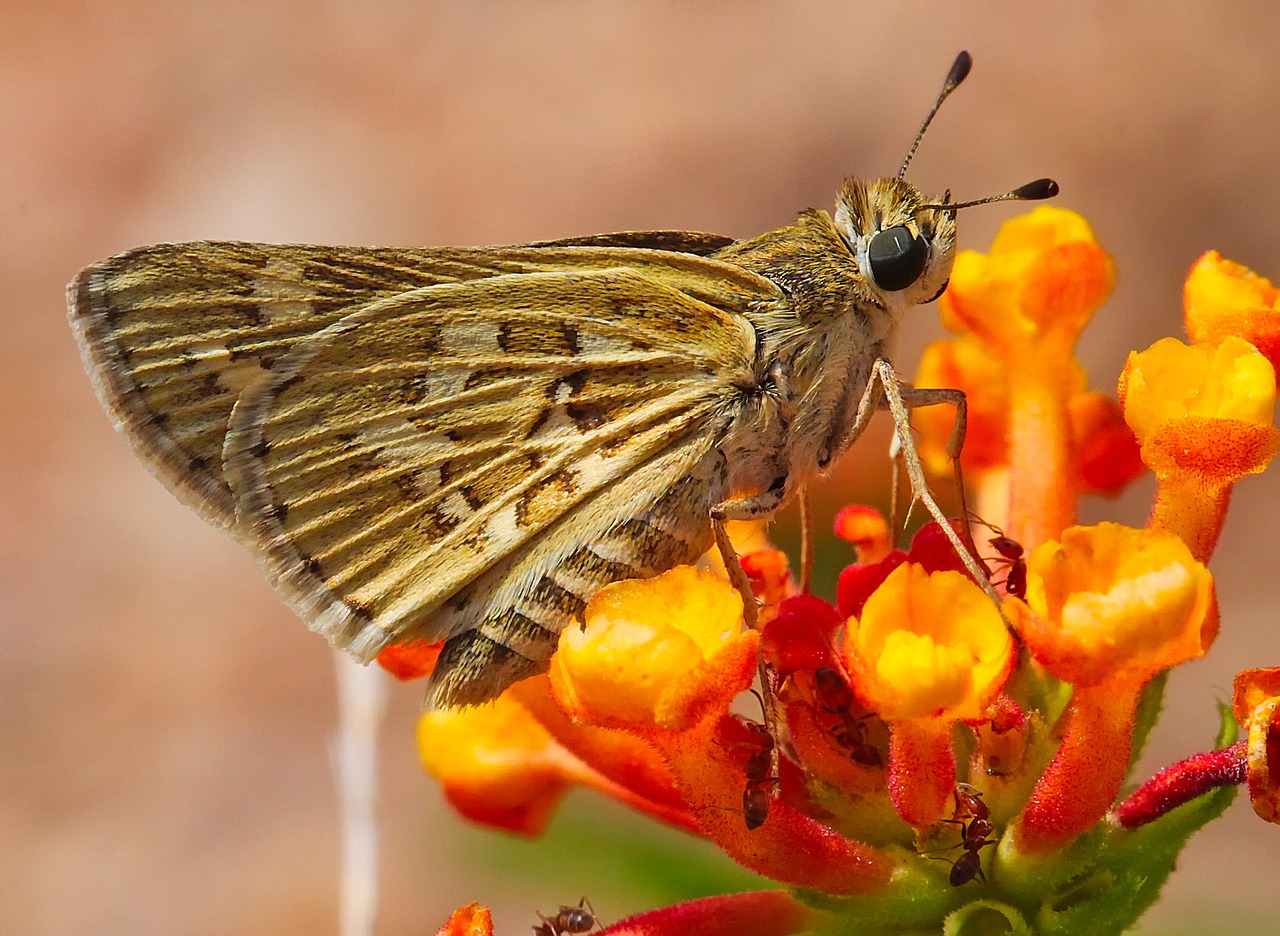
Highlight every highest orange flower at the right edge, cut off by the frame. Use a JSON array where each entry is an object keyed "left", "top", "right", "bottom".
[{"left": 1183, "top": 250, "right": 1280, "bottom": 366}]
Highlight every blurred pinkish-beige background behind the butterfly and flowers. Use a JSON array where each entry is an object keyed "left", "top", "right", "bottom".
[{"left": 0, "top": 0, "right": 1280, "bottom": 936}]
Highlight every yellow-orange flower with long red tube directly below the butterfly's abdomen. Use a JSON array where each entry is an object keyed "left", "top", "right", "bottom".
[{"left": 550, "top": 567, "right": 891, "bottom": 894}]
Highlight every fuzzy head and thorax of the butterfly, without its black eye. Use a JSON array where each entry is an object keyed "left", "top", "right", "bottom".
[{"left": 716, "top": 178, "right": 955, "bottom": 501}]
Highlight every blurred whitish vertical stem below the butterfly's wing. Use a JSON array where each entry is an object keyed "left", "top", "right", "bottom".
[{"left": 332, "top": 650, "right": 387, "bottom": 936}]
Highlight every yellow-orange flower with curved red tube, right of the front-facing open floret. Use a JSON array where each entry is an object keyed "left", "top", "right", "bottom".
[{"left": 1006, "top": 524, "right": 1217, "bottom": 853}]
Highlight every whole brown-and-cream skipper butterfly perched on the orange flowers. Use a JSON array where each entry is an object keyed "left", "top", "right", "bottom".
[{"left": 68, "top": 54, "right": 1056, "bottom": 706}]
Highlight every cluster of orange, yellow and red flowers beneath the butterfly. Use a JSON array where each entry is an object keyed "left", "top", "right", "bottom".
[{"left": 394, "top": 207, "right": 1280, "bottom": 936}]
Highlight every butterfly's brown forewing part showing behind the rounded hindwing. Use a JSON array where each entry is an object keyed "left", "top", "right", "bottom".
[{"left": 68, "top": 230, "right": 731, "bottom": 529}]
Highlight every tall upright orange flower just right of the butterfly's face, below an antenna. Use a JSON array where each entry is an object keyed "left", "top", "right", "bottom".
[{"left": 916, "top": 207, "right": 1115, "bottom": 545}]
